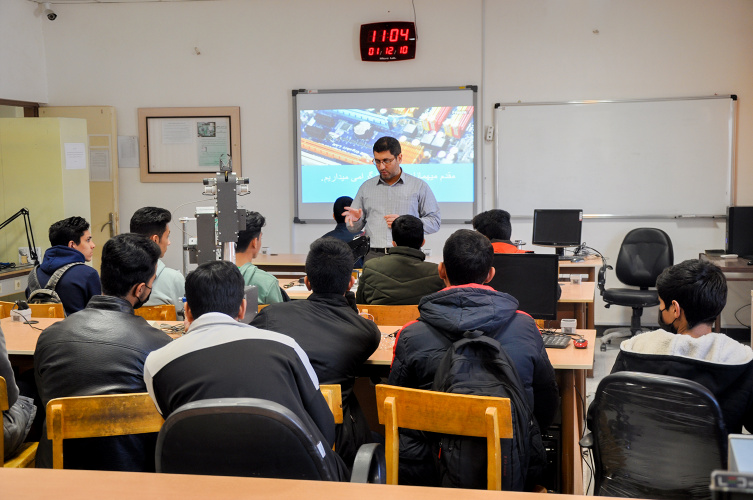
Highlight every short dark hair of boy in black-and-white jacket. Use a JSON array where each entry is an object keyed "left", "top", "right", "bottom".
[{"left": 186, "top": 260, "right": 245, "bottom": 319}]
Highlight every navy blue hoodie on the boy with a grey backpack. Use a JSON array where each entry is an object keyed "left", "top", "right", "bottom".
[{"left": 26, "top": 245, "right": 102, "bottom": 315}]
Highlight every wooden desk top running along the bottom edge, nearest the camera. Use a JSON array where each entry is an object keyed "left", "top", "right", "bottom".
[{"left": 0, "top": 467, "right": 628, "bottom": 500}]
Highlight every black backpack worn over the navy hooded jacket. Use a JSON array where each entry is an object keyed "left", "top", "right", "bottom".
[{"left": 432, "top": 331, "right": 547, "bottom": 491}]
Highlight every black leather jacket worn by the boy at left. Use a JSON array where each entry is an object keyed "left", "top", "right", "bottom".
[{"left": 34, "top": 295, "right": 171, "bottom": 471}]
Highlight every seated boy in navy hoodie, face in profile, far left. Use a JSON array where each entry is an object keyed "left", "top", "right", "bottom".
[{"left": 26, "top": 217, "right": 102, "bottom": 315}]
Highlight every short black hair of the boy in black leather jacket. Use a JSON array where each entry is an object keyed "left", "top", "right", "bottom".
[{"left": 99, "top": 233, "right": 162, "bottom": 298}]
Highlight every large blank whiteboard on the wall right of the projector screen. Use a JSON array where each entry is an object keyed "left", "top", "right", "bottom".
[{"left": 495, "top": 96, "right": 736, "bottom": 217}]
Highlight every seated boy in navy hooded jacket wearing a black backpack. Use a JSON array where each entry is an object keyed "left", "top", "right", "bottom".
[{"left": 389, "top": 229, "right": 559, "bottom": 486}]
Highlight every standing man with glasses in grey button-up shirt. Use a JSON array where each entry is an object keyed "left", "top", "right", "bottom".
[{"left": 343, "top": 137, "right": 441, "bottom": 261}]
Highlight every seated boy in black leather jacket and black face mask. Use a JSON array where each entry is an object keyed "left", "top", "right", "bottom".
[{"left": 34, "top": 233, "right": 172, "bottom": 472}]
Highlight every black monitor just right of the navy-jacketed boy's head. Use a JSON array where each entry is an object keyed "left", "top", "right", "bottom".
[{"left": 489, "top": 253, "right": 559, "bottom": 319}]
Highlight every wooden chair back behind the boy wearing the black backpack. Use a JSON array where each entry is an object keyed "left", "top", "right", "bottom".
[{"left": 376, "top": 384, "right": 513, "bottom": 490}]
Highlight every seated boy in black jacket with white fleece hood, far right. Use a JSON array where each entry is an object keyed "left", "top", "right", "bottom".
[{"left": 612, "top": 259, "right": 753, "bottom": 434}]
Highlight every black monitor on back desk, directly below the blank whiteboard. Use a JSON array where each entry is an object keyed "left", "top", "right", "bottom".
[{"left": 531, "top": 209, "right": 583, "bottom": 259}]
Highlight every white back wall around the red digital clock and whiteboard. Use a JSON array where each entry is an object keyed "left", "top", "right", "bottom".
[{"left": 5, "top": 0, "right": 753, "bottom": 324}]
